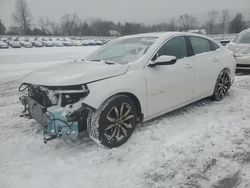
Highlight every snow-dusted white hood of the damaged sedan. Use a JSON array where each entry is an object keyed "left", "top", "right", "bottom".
[{"left": 22, "top": 61, "right": 128, "bottom": 86}]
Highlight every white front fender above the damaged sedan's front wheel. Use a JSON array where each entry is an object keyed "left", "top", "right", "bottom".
[{"left": 84, "top": 70, "right": 147, "bottom": 116}]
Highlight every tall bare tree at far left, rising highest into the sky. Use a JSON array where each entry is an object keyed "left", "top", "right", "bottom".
[{"left": 12, "top": 0, "right": 32, "bottom": 35}]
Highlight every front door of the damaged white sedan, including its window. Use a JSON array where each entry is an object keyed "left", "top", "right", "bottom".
[{"left": 145, "top": 37, "right": 194, "bottom": 117}]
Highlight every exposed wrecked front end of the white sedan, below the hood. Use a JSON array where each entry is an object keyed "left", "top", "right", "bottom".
[{"left": 19, "top": 83, "right": 92, "bottom": 143}]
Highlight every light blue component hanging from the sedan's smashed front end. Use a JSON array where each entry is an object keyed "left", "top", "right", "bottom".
[{"left": 44, "top": 106, "right": 79, "bottom": 143}]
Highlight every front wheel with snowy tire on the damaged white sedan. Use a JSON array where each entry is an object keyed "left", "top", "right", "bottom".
[{"left": 87, "top": 95, "right": 138, "bottom": 148}]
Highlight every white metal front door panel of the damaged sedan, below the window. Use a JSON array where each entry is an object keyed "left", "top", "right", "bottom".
[{"left": 145, "top": 58, "right": 194, "bottom": 116}]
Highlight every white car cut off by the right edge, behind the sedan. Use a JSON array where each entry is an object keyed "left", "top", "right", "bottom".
[{"left": 227, "top": 28, "right": 250, "bottom": 70}]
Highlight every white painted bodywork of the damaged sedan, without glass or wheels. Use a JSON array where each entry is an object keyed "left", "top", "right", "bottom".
[{"left": 23, "top": 32, "right": 236, "bottom": 120}]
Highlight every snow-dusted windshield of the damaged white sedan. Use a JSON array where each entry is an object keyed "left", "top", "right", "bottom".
[{"left": 86, "top": 37, "right": 157, "bottom": 64}]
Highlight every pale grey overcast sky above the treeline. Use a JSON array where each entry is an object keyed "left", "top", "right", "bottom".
[{"left": 0, "top": 0, "right": 250, "bottom": 26}]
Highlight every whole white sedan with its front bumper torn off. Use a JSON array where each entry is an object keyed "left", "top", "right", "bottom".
[{"left": 19, "top": 32, "right": 236, "bottom": 148}]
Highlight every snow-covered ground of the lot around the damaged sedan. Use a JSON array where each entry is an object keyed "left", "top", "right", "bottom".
[{"left": 0, "top": 47, "right": 250, "bottom": 188}]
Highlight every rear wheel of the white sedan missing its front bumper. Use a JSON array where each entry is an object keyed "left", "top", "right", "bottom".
[{"left": 212, "top": 70, "right": 231, "bottom": 101}]
